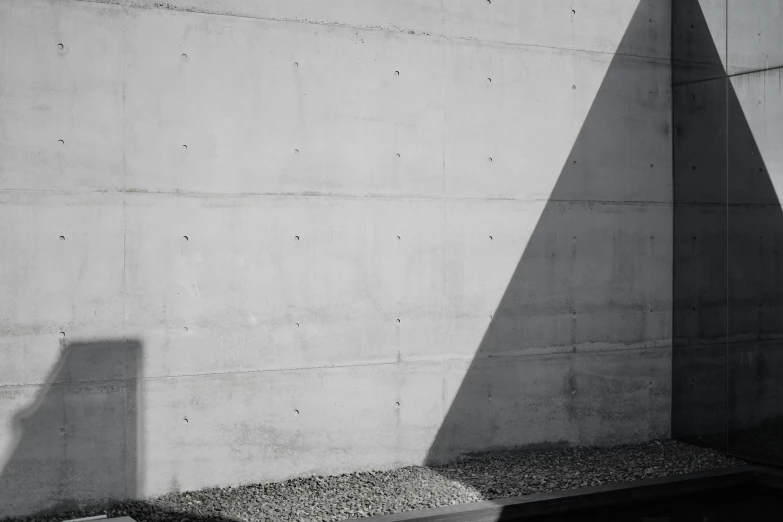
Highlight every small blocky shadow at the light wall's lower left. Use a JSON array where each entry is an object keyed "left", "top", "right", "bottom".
[{"left": 0, "top": 341, "right": 143, "bottom": 520}]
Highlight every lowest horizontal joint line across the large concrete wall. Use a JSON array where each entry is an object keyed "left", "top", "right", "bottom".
[{"left": 0, "top": 346, "right": 670, "bottom": 389}]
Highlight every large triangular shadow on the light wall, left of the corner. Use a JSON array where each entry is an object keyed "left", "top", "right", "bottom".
[{"left": 426, "top": 0, "right": 671, "bottom": 476}]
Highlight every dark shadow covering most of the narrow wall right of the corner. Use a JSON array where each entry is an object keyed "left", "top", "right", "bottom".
[{"left": 672, "top": 0, "right": 783, "bottom": 463}]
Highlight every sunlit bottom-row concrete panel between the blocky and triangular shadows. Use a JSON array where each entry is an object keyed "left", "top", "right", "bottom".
[{"left": 132, "top": 364, "right": 442, "bottom": 495}]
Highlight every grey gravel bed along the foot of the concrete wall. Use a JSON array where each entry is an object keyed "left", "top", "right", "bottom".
[{"left": 5, "top": 440, "right": 744, "bottom": 522}]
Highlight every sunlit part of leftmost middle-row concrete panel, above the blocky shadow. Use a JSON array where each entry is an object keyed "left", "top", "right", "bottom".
[{"left": 0, "top": 192, "right": 124, "bottom": 384}]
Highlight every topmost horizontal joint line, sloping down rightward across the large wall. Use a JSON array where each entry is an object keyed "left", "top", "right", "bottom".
[{"left": 75, "top": 0, "right": 671, "bottom": 63}]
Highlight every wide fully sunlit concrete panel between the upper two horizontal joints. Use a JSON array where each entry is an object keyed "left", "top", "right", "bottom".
[{"left": 126, "top": 10, "right": 444, "bottom": 199}]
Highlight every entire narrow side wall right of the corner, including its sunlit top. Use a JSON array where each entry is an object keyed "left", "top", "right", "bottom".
[{"left": 672, "top": 0, "right": 783, "bottom": 462}]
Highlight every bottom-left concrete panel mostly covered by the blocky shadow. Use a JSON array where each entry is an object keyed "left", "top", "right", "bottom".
[{"left": 0, "top": 381, "right": 126, "bottom": 516}]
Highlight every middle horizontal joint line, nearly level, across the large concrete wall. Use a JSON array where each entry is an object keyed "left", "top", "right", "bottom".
[{"left": 0, "top": 186, "right": 672, "bottom": 206}]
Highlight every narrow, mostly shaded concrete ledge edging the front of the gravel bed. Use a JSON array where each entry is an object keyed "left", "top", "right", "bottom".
[{"left": 354, "top": 466, "right": 760, "bottom": 522}]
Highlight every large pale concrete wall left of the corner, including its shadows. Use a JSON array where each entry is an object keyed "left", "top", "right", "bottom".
[{"left": 0, "top": 0, "right": 672, "bottom": 514}]
